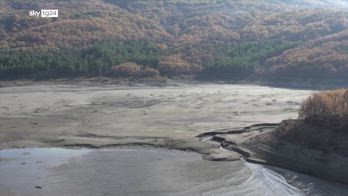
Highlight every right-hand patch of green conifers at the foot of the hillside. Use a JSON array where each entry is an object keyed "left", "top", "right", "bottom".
[{"left": 198, "top": 40, "right": 298, "bottom": 79}]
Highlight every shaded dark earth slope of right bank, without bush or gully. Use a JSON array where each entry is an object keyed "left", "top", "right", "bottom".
[{"left": 241, "top": 121, "right": 348, "bottom": 183}]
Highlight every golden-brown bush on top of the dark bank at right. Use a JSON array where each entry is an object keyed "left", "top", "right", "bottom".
[{"left": 299, "top": 89, "right": 348, "bottom": 128}]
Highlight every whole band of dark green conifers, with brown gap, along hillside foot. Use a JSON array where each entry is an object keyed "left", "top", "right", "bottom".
[{"left": 0, "top": 40, "right": 296, "bottom": 79}]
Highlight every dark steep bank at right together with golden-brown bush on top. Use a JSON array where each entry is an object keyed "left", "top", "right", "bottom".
[{"left": 240, "top": 89, "right": 348, "bottom": 183}]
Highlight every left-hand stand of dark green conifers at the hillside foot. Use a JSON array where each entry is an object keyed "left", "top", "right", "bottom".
[{"left": 0, "top": 41, "right": 159, "bottom": 79}]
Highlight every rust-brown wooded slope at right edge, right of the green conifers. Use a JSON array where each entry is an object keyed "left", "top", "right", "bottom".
[{"left": 267, "top": 31, "right": 348, "bottom": 78}]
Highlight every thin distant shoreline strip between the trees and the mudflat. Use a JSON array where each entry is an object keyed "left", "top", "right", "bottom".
[{"left": 0, "top": 76, "right": 348, "bottom": 90}]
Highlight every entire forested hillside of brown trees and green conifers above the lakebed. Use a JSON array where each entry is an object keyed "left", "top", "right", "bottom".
[{"left": 0, "top": 0, "right": 348, "bottom": 81}]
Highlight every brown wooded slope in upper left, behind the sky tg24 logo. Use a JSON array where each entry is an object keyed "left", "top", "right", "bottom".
[{"left": 0, "top": 0, "right": 169, "bottom": 48}]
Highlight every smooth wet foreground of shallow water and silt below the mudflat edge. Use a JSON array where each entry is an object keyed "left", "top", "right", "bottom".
[{"left": 0, "top": 148, "right": 348, "bottom": 196}]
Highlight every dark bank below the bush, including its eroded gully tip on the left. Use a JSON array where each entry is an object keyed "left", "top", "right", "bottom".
[{"left": 198, "top": 120, "right": 348, "bottom": 184}]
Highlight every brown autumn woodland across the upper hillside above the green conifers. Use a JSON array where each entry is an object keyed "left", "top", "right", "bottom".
[{"left": 0, "top": 0, "right": 348, "bottom": 47}]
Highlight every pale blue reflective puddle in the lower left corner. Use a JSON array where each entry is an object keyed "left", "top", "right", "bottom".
[{"left": 0, "top": 148, "right": 90, "bottom": 196}]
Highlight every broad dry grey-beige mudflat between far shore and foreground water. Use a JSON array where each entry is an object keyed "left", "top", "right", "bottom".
[{"left": 4, "top": 82, "right": 346, "bottom": 190}]
